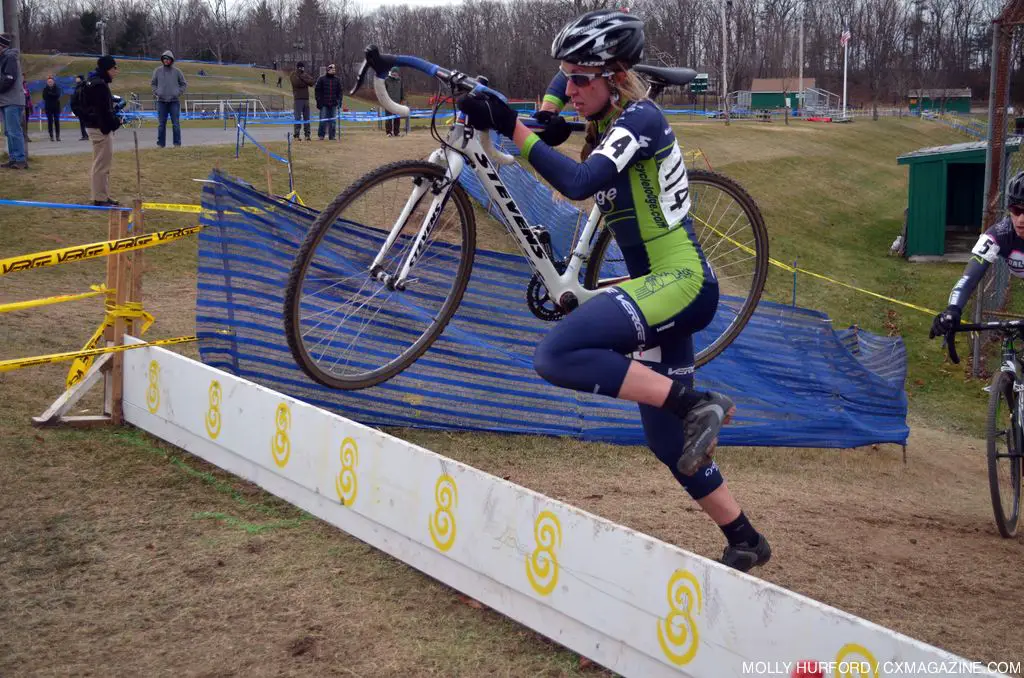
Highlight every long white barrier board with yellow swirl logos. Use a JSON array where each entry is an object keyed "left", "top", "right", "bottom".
[{"left": 124, "top": 339, "right": 998, "bottom": 678}]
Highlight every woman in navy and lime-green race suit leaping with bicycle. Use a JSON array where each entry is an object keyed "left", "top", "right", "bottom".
[{"left": 459, "top": 10, "right": 771, "bottom": 571}]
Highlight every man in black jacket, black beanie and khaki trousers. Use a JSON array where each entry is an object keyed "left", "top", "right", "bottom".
[{"left": 82, "top": 54, "right": 121, "bottom": 206}]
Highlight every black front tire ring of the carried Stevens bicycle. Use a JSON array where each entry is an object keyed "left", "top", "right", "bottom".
[{"left": 284, "top": 160, "right": 476, "bottom": 390}]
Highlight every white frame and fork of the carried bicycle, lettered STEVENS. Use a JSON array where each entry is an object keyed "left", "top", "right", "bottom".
[{"left": 370, "top": 120, "right": 601, "bottom": 309}]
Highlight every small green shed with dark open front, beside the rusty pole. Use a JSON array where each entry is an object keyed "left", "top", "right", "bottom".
[{"left": 896, "top": 136, "right": 1021, "bottom": 258}]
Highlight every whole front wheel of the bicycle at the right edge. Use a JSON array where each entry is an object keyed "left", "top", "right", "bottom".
[{"left": 987, "top": 372, "right": 1022, "bottom": 538}]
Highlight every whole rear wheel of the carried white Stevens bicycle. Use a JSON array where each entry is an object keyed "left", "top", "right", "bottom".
[{"left": 584, "top": 170, "right": 768, "bottom": 367}]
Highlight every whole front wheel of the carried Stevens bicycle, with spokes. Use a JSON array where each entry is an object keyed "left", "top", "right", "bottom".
[{"left": 285, "top": 161, "right": 476, "bottom": 390}]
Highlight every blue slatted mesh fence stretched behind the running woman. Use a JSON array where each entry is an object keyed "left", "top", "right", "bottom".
[{"left": 197, "top": 168, "right": 908, "bottom": 448}]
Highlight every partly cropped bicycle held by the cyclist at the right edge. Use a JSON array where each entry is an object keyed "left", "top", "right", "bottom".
[{"left": 945, "top": 320, "right": 1024, "bottom": 539}]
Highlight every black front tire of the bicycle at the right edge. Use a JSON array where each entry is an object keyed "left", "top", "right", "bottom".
[{"left": 986, "top": 371, "right": 1022, "bottom": 539}]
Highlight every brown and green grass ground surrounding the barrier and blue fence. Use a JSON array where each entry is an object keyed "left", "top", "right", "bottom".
[{"left": 0, "top": 111, "right": 1024, "bottom": 676}]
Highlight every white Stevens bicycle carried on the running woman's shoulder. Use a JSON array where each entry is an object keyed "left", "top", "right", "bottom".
[{"left": 284, "top": 46, "right": 768, "bottom": 390}]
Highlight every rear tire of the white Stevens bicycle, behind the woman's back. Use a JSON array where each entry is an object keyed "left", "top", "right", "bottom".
[{"left": 584, "top": 170, "right": 768, "bottom": 367}]
